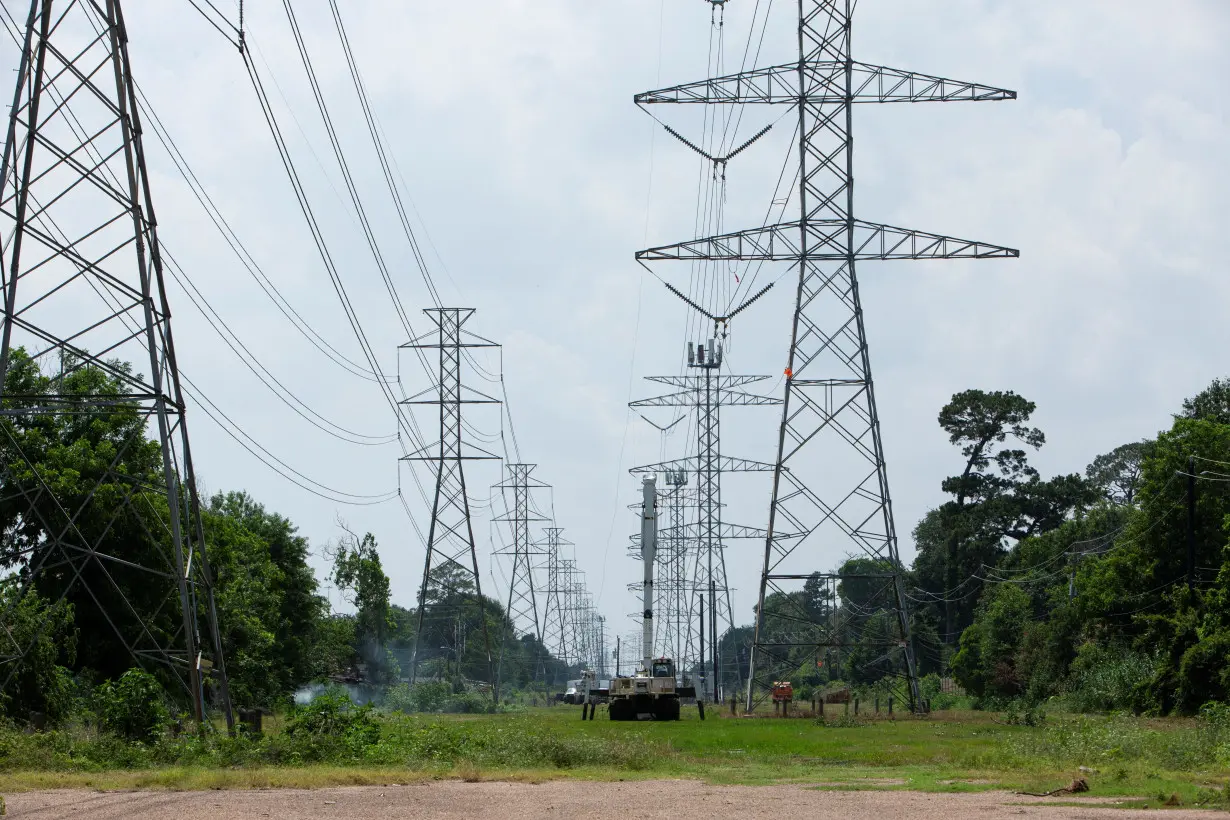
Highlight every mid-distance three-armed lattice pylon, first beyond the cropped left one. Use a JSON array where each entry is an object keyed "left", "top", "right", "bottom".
[{"left": 401, "top": 307, "right": 499, "bottom": 684}]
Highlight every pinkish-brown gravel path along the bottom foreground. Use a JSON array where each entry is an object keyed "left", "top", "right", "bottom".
[{"left": 7, "top": 781, "right": 1224, "bottom": 820}]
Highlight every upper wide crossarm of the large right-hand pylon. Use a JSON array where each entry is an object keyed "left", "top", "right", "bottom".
[{"left": 633, "top": 60, "right": 1016, "bottom": 106}]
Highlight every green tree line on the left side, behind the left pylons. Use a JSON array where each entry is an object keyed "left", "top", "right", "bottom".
[{"left": 0, "top": 349, "right": 568, "bottom": 720}]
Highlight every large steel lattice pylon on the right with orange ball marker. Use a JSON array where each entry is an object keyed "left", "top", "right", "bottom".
[{"left": 635, "top": 0, "right": 1020, "bottom": 709}]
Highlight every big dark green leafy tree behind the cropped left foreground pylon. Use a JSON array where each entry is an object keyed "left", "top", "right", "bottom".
[{"left": 0, "top": 348, "right": 183, "bottom": 695}]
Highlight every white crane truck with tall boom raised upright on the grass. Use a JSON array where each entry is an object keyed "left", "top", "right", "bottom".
[{"left": 602, "top": 476, "right": 705, "bottom": 720}]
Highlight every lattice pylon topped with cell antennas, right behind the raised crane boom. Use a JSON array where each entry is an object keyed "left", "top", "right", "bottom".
[{"left": 630, "top": 339, "right": 781, "bottom": 698}]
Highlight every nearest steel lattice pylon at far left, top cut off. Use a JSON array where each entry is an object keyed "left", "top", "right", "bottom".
[{"left": 0, "top": 0, "right": 232, "bottom": 725}]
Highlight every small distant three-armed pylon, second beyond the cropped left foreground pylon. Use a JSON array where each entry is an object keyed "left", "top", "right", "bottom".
[{"left": 496, "top": 463, "right": 549, "bottom": 682}]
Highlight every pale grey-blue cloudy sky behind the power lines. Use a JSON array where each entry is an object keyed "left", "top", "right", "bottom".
[{"left": 4, "top": 0, "right": 1230, "bottom": 649}]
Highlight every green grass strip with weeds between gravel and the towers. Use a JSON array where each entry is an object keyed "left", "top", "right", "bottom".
[{"left": 0, "top": 707, "right": 1230, "bottom": 808}]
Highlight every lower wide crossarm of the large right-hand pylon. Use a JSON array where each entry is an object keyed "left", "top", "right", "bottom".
[{"left": 636, "top": 219, "right": 1021, "bottom": 262}]
